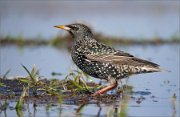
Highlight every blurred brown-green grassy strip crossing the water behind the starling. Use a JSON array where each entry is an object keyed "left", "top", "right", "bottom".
[{"left": 0, "top": 33, "right": 180, "bottom": 48}]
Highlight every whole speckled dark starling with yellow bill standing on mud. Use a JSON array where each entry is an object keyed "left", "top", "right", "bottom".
[{"left": 54, "top": 23, "right": 161, "bottom": 95}]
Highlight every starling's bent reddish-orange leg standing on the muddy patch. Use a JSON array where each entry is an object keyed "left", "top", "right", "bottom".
[{"left": 92, "top": 78, "right": 118, "bottom": 96}]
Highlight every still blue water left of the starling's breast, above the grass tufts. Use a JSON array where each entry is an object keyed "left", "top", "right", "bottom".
[{"left": 0, "top": 46, "right": 72, "bottom": 77}]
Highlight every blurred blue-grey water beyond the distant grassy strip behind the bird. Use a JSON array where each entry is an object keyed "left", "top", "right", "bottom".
[{"left": 0, "top": 0, "right": 180, "bottom": 39}]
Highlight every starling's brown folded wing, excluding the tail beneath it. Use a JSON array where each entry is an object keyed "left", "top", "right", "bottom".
[{"left": 85, "top": 54, "right": 159, "bottom": 67}]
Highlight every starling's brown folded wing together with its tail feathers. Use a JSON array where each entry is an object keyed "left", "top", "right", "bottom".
[{"left": 85, "top": 54, "right": 161, "bottom": 72}]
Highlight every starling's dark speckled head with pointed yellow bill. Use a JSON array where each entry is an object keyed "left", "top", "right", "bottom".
[{"left": 54, "top": 23, "right": 92, "bottom": 37}]
